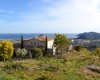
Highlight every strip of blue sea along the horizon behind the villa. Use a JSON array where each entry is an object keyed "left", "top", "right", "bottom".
[{"left": 0, "top": 33, "right": 77, "bottom": 40}]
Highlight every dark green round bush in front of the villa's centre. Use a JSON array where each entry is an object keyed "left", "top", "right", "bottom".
[{"left": 31, "top": 47, "right": 43, "bottom": 59}]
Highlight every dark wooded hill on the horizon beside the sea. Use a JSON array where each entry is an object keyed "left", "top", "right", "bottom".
[{"left": 77, "top": 32, "right": 100, "bottom": 40}]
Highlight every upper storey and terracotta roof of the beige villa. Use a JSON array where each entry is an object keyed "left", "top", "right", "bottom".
[{"left": 23, "top": 36, "right": 54, "bottom": 49}]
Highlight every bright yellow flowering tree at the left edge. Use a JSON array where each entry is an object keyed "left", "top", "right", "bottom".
[{"left": 0, "top": 41, "right": 14, "bottom": 61}]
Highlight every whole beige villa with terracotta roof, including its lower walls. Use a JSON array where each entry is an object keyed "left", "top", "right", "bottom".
[{"left": 13, "top": 36, "right": 56, "bottom": 55}]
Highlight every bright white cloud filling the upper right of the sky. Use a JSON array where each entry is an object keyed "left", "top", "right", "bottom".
[{"left": 40, "top": 0, "right": 100, "bottom": 32}]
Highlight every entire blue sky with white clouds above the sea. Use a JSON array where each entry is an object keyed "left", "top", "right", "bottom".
[{"left": 0, "top": 0, "right": 100, "bottom": 33}]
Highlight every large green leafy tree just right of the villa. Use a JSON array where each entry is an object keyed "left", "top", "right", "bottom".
[{"left": 54, "top": 34, "right": 69, "bottom": 51}]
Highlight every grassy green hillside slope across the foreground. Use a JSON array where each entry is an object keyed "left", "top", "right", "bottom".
[{"left": 0, "top": 52, "right": 100, "bottom": 80}]
